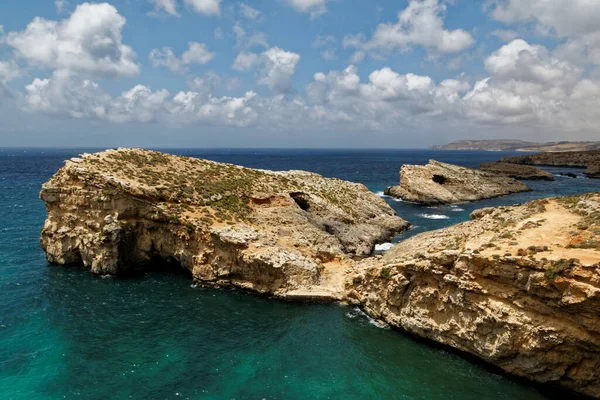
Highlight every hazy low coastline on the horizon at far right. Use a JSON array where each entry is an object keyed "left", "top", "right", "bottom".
[{"left": 431, "top": 139, "right": 600, "bottom": 152}]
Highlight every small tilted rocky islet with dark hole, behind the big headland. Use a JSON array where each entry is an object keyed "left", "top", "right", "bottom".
[{"left": 384, "top": 160, "right": 530, "bottom": 205}]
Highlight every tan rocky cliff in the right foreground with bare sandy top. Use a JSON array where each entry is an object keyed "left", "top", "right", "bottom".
[{"left": 347, "top": 195, "right": 600, "bottom": 398}]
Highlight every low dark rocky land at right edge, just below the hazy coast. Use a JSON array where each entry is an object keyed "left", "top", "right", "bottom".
[{"left": 502, "top": 150, "right": 600, "bottom": 178}]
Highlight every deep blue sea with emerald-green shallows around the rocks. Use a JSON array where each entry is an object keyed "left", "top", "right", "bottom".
[{"left": 0, "top": 149, "right": 600, "bottom": 400}]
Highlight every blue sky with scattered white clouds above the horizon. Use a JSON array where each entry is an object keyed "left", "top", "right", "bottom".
[{"left": 0, "top": 0, "right": 600, "bottom": 148}]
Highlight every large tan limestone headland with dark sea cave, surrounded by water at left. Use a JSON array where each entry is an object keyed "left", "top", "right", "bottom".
[{"left": 40, "top": 149, "right": 410, "bottom": 299}]
